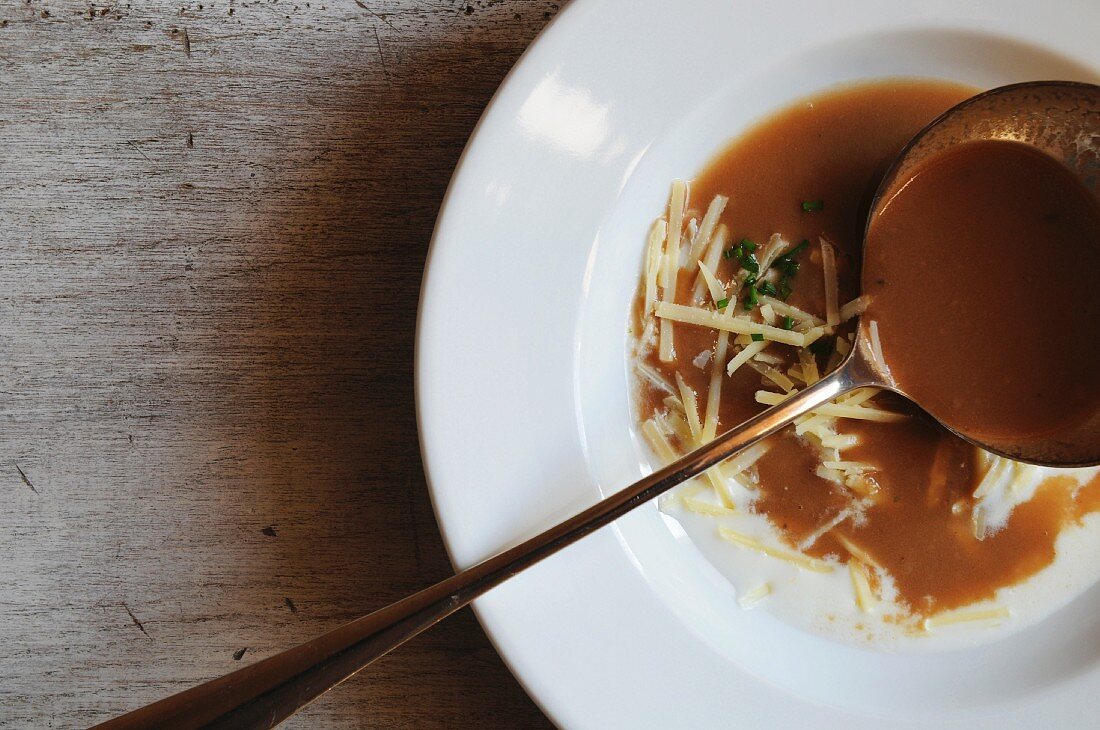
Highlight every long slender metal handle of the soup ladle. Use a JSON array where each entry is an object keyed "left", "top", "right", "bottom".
[{"left": 96, "top": 358, "right": 865, "bottom": 730}]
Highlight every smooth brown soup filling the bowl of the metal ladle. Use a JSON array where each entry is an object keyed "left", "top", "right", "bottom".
[{"left": 864, "top": 137, "right": 1100, "bottom": 443}]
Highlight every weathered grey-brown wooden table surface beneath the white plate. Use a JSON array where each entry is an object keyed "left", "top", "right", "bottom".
[{"left": 0, "top": 0, "right": 558, "bottom": 728}]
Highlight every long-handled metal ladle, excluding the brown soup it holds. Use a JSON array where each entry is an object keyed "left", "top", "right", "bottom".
[{"left": 97, "top": 81, "right": 1100, "bottom": 730}]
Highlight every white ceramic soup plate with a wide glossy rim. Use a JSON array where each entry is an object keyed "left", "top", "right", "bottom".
[{"left": 417, "top": 0, "right": 1100, "bottom": 730}]
